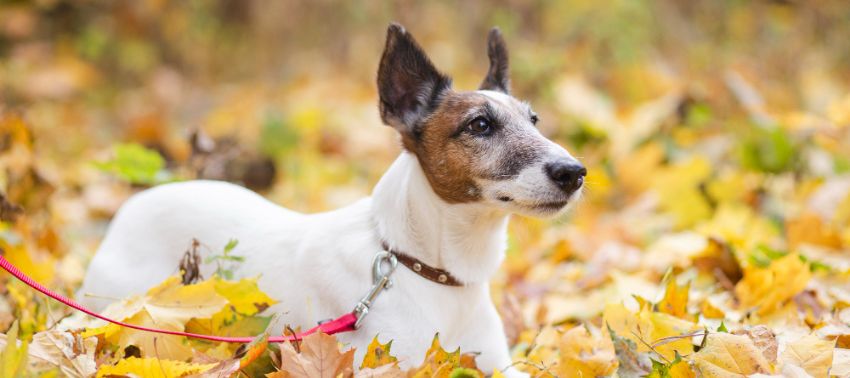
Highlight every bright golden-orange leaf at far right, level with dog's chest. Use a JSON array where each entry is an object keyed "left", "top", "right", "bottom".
[{"left": 735, "top": 253, "right": 812, "bottom": 315}]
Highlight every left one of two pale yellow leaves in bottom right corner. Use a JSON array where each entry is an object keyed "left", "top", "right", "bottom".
[{"left": 691, "top": 333, "right": 771, "bottom": 378}]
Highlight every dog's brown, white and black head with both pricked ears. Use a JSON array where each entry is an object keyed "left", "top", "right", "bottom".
[{"left": 378, "top": 24, "right": 587, "bottom": 216}]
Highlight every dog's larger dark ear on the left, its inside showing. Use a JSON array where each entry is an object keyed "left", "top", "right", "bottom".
[{"left": 378, "top": 23, "right": 451, "bottom": 134}]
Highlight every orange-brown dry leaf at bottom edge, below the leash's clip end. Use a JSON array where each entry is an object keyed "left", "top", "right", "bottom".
[{"left": 280, "top": 332, "right": 354, "bottom": 378}]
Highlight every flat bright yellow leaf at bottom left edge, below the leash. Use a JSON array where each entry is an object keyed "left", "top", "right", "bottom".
[{"left": 97, "top": 357, "right": 216, "bottom": 378}]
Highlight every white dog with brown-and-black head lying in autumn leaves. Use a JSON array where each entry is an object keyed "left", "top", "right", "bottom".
[{"left": 78, "top": 23, "right": 587, "bottom": 376}]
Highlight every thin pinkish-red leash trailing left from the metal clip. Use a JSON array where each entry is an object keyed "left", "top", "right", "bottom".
[{"left": 0, "top": 249, "right": 357, "bottom": 343}]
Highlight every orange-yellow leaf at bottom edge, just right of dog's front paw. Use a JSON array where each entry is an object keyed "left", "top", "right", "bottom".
[{"left": 558, "top": 324, "right": 618, "bottom": 377}]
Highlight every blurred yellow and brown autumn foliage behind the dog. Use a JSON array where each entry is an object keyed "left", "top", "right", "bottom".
[{"left": 0, "top": 0, "right": 850, "bottom": 372}]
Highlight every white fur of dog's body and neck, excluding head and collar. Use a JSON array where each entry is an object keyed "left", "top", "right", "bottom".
[{"left": 78, "top": 152, "right": 522, "bottom": 376}]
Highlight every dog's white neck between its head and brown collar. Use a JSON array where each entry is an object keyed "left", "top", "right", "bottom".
[{"left": 372, "top": 151, "right": 508, "bottom": 285}]
